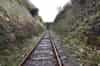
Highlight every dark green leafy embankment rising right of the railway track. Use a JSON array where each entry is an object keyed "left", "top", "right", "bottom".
[{"left": 51, "top": 0, "right": 100, "bottom": 66}]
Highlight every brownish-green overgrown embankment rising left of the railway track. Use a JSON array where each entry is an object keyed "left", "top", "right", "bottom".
[{"left": 0, "top": 0, "right": 44, "bottom": 66}]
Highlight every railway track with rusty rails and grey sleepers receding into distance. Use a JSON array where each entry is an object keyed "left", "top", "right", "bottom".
[{"left": 20, "top": 32, "right": 72, "bottom": 66}]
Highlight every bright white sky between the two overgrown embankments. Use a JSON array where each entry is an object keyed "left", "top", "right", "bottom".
[{"left": 29, "top": 0, "right": 70, "bottom": 22}]
